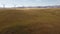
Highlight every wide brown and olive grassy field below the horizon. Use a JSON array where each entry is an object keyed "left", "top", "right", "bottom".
[{"left": 0, "top": 8, "right": 60, "bottom": 34}]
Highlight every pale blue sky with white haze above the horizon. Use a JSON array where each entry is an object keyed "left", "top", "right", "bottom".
[{"left": 0, "top": 0, "right": 60, "bottom": 7}]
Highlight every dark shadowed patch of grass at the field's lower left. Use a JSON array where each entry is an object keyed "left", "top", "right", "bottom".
[{"left": 1, "top": 26, "right": 29, "bottom": 34}]
